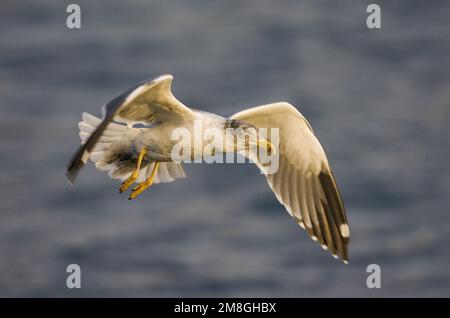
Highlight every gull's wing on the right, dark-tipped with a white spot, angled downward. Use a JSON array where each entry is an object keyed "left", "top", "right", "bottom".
[{"left": 231, "top": 102, "right": 350, "bottom": 262}]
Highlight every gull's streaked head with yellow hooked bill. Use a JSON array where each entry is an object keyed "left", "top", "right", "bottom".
[{"left": 224, "top": 119, "right": 275, "bottom": 153}]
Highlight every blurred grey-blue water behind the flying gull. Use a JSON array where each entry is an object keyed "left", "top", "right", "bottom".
[{"left": 0, "top": 0, "right": 450, "bottom": 297}]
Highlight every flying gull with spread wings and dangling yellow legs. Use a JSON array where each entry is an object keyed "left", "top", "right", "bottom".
[{"left": 66, "top": 74, "right": 350, "bottom": 264}]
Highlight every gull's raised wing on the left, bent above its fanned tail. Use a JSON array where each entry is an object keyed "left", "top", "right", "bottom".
[{"left": 66, "top": 75, "right": 194, "bottom": 183}]
